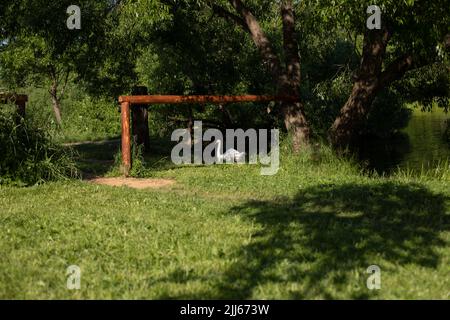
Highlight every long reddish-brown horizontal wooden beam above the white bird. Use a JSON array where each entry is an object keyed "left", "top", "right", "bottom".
[{"left": 119, "top": 95, "right": 299, "bottom": 104}]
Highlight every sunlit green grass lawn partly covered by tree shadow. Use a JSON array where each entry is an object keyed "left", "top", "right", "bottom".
[{"left": 0, "top": 141, "right": 450, "bottom": 299}]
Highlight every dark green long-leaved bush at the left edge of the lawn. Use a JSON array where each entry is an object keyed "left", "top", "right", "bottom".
[{"left": 0, "top": 109, "right": 78, "bottom": 186}]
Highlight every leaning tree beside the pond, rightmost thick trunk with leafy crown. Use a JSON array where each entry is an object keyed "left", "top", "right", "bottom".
[{"left": 319, "top": 0, "right": 450, "bottom": 148}]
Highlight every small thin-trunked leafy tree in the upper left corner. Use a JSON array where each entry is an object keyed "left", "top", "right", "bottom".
[{"left": 0, "top": 0, "right": 111, "bottom": 124}]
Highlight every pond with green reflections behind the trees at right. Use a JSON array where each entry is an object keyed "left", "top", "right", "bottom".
[{"left": 360, "top": 108, "right": 450, "bottom": 174}]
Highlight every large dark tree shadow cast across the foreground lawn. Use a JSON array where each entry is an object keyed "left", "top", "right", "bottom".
[{"left": 202, "top": 182, "right": 450, "bottom": 299}]
